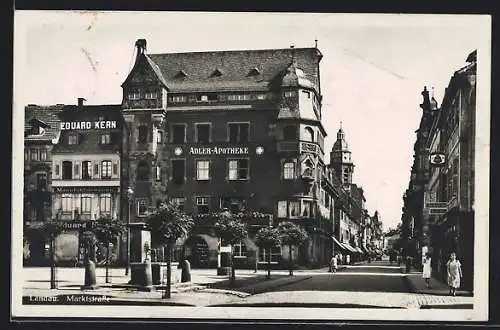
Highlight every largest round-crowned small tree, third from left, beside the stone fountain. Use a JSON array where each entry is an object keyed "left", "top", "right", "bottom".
[{"left": 148, "top": 203, "right": 194, "bottom": 298}]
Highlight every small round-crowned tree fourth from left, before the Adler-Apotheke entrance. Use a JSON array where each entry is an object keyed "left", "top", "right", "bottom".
[{"left": 214, "top": 211, "right": 248, "bottom": 285}]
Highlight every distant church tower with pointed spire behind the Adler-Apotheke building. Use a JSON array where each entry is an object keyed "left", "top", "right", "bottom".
[{"left": 329, "top": 122, "right": 354, "bottom": 185}]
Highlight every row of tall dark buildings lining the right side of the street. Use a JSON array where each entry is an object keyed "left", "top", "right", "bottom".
[{"left": 402, "top": 51, "right": 476, "bottom": 290}]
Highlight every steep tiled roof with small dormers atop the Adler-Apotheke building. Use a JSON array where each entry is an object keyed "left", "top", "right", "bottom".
[{"left": 147, "top": 48, "right": 322, "bottom": 92}]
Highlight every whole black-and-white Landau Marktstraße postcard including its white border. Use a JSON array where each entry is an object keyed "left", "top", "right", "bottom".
[{"left": 11, "top": 10, "right": 491, "bottom": 321}]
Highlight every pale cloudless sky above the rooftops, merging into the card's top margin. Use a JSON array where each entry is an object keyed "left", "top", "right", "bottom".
[{"left": 14, "top": 11, "right": 490, "bottom": 229}]
